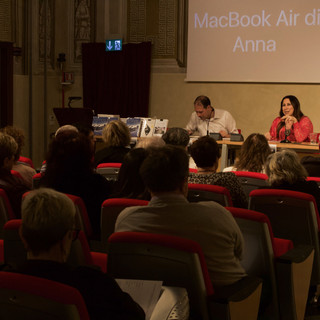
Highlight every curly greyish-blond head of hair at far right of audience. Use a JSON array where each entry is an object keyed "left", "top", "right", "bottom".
[{"left": 266, "top": 149, "right": 308, "bottom": 186}]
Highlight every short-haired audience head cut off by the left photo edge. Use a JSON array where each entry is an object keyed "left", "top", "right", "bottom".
[{"left": 0, "top": 132, "right": 18, "bottom": 170}]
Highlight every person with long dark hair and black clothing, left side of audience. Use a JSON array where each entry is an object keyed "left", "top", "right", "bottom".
[{"left": 40, "top": 131, "right": 111, "bottom": 236}]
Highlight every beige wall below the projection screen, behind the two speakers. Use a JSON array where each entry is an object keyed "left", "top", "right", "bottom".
[{"left": 149, "top": 73, "right": 320, "bottom": 137}]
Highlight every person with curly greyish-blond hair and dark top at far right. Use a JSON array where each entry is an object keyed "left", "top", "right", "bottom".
[{"left": 266, "top": 149, "right": 320, "bottom": 208}]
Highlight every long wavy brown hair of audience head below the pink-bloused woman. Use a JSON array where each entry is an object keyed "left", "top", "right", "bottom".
[{"left": 235, "top": 133, "right": 271, "bottom": 172}]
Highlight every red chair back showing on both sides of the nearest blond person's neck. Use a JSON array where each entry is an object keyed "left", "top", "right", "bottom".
[{"left": 4, "top": 219, "right": 94, "bottom": 267}]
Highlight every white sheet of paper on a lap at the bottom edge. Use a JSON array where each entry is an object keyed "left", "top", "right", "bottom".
[{"left": 116, "top": 279, "right": 162, "bottom": 320}]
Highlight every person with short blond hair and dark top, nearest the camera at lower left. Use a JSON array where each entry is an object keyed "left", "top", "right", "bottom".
[{"left": 14, "top": 188, "right": 145, "bottom": 319}]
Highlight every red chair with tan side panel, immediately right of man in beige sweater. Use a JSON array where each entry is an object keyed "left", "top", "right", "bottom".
[{"left": 226, "top": 207, "right": 314, "bottom": 319}]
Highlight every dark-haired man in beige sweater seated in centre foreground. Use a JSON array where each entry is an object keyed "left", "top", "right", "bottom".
[{"left": 115, "top": 146, "right": 246, "bottom": 287}]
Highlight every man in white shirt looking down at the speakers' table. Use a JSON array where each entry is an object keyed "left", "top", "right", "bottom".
[{"left": 186, "top": 96, "right": 238, "bottom": 138}]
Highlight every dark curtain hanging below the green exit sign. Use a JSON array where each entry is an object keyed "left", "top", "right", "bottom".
[{"left": 82, "top": 42, "right": 151, "bottom": 118}]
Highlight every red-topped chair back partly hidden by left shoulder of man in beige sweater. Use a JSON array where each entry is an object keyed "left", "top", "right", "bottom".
[{"left": 100, "top": 198, "right": 149, "bottom": 243}]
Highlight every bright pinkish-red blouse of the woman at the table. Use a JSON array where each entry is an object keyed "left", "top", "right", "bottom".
[{"left": 269, "top": 116, "right": 313, "bottom": 142}]
